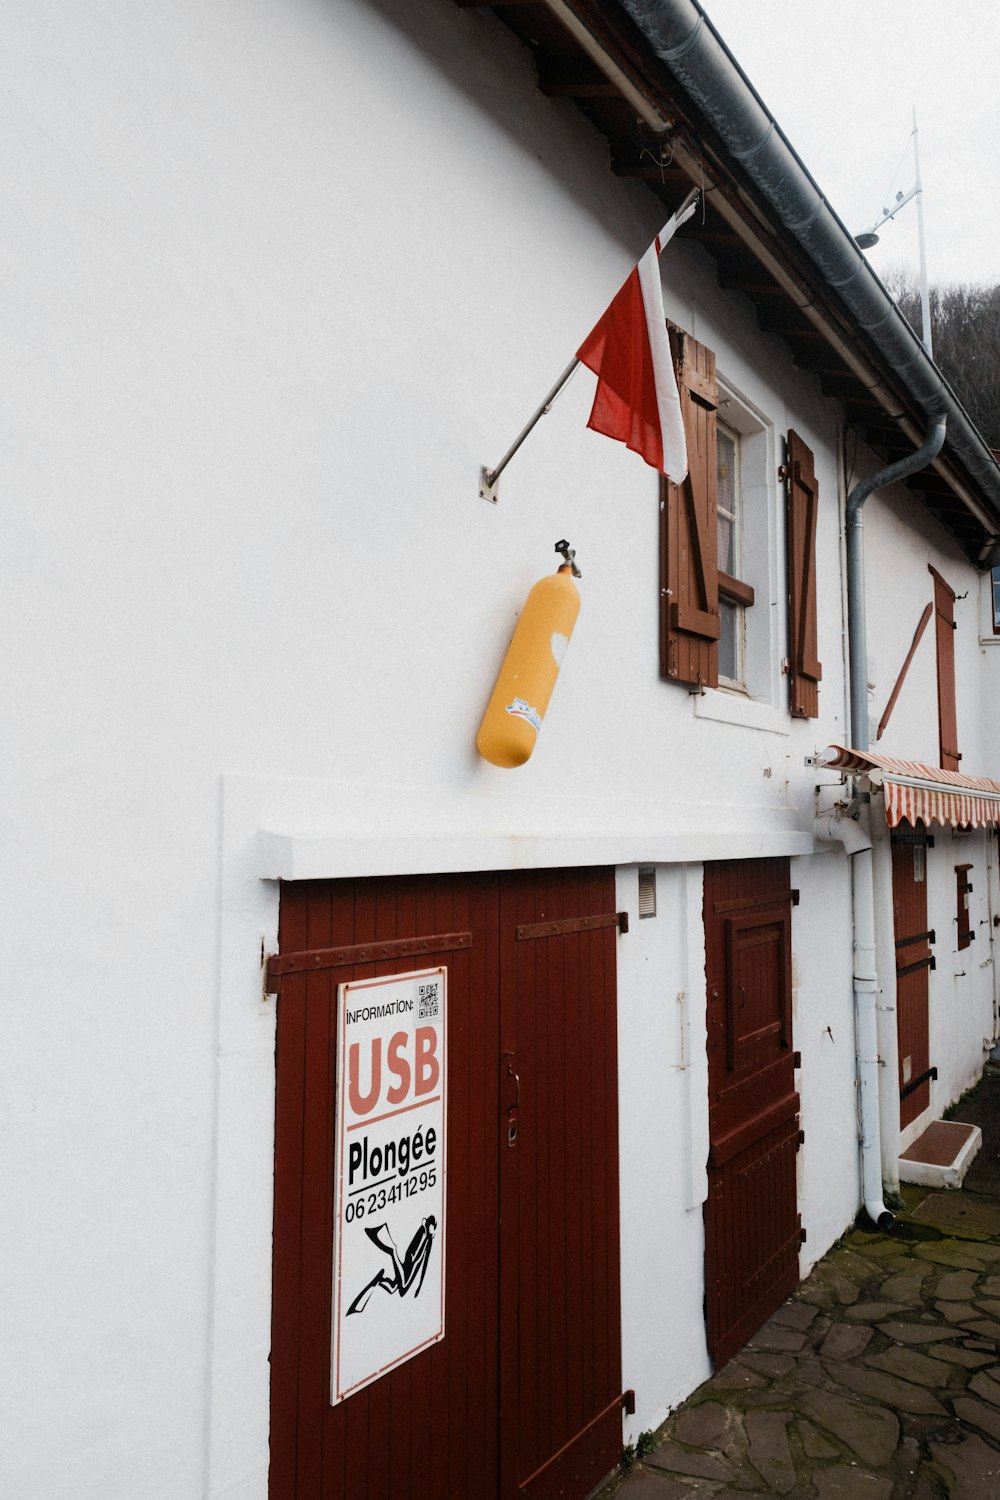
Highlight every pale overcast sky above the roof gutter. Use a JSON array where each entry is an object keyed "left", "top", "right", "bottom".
[{"left": 702, "top": 0, "right": 1000, "bottom": 285}]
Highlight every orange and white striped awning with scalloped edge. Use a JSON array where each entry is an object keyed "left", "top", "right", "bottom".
[{"left": 823, "top": 746, "right": 1000, "bottom": 828}]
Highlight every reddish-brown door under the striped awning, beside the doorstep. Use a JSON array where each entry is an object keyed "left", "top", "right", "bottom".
[{"left": 892, "top": 822, "right": 934, "bottom": 1125}]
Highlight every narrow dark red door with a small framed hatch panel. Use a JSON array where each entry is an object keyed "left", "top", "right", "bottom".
[{"left": 705, "top": 860, "right": 801, "bottom": 1367}]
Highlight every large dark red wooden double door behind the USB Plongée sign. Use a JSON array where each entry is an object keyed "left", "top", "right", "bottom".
[{"left": 270, "top": 870, "right": 621, "bottom": 1500}]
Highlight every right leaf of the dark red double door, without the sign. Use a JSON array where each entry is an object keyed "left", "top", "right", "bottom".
[{"left": 501, "top": 870, "right": 622, "bottom": 1500}]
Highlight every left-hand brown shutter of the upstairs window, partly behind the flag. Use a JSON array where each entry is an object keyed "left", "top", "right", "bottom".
[{"left": 660, "top": 324, "right": 720, "bottom": 687}]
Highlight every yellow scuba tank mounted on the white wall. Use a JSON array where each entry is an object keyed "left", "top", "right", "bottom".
[{"left": 475, "top": 542, "right": 580, "bottom": 767}]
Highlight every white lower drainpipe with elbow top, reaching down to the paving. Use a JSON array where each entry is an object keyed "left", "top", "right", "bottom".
[{"left": 814, "top": 813, "right": 894, "bottom": 1229}]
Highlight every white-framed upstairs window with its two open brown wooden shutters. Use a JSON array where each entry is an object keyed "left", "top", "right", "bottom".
[{"left": 658, "top": 333, "right": 803, "bottom": 734}]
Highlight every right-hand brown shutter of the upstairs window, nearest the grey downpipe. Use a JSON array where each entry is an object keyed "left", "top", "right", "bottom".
[{"left": 786, "top": 432, "right": 823, "bottom": 719}]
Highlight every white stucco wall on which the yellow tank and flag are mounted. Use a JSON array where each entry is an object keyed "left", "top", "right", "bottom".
[{"left": 0, "top": 0, "right": 995, "bottom": 1500}]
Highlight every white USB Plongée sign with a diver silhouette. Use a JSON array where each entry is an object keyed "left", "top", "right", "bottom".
[{"left": 330, "top": 968, "right": 448, "bottom": 1406}]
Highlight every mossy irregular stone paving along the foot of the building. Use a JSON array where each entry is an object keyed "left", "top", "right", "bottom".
[{"left": 600, "top": 1062, "right": 1000, "bottom": 1500}]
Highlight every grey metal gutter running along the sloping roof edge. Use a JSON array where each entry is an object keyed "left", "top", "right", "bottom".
[{"left": 618, "top": 0, "right": 1000, "bottom": 563}]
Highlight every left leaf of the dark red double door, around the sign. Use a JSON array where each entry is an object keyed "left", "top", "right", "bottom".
[{"left": 270, "top": 875, "right": 499, "bottom": 1500}]
